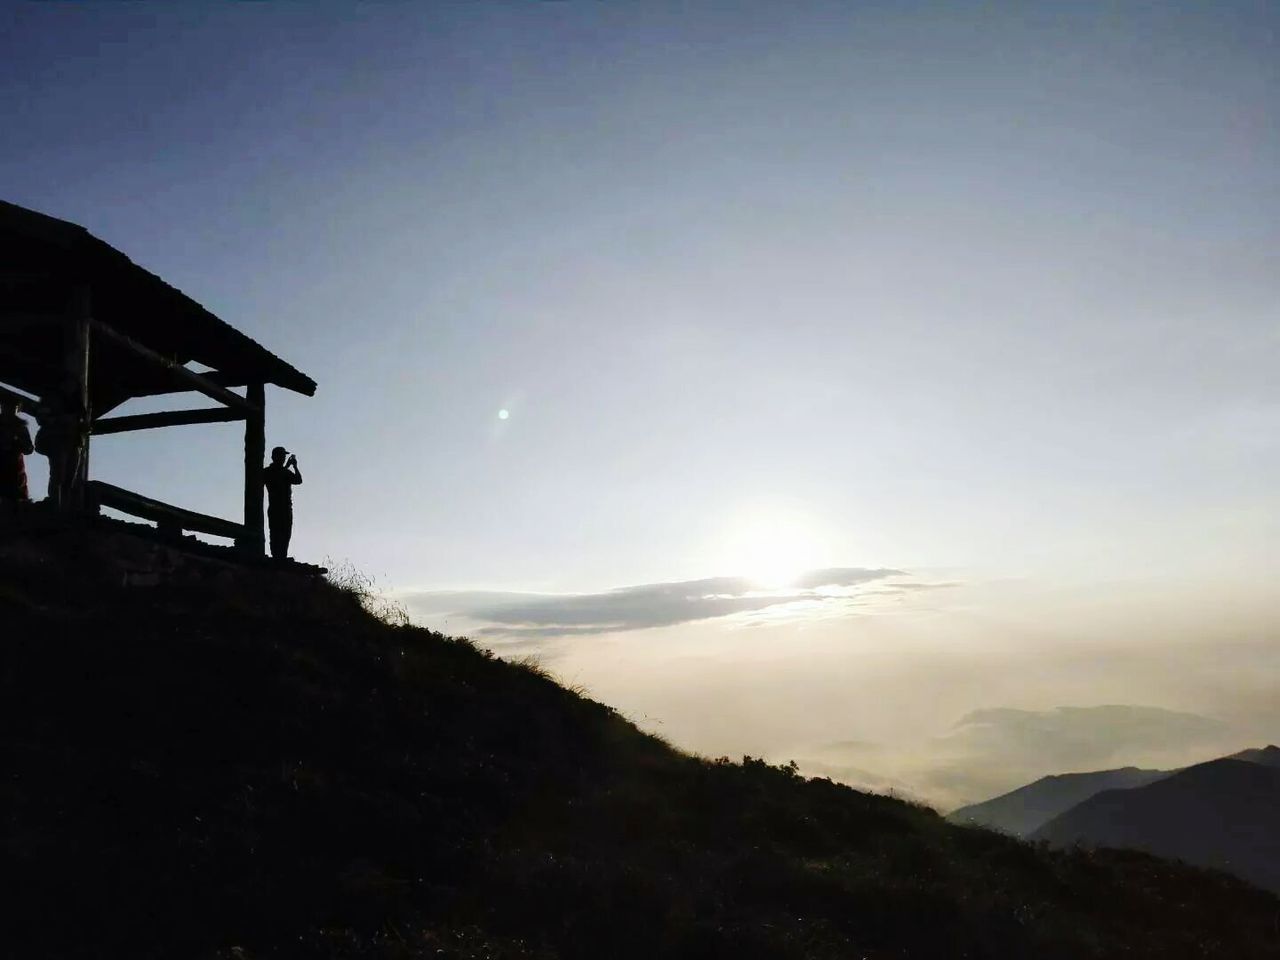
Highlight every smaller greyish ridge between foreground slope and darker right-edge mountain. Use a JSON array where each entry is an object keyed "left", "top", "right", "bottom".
[{"left": 947, "top": 767, "right": 1169, "bottom": 837}]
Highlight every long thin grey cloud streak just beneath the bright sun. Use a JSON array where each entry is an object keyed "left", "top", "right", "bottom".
[{"left": 398, "top": 567, "right": 929, "bottom": 639}]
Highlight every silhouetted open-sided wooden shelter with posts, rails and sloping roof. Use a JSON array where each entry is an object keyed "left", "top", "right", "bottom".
[{"left": 0, "top": 201, "right": 316, "bottom": 556}]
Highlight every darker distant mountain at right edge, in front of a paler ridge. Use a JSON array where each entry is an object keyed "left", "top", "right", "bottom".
[{"left": 1033, "top": 751, "right": 1280, "bottom": 892}]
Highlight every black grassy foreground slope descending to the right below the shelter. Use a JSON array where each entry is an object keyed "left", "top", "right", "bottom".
[{"left": 0, "top": 560, "right": 1280, "bottom": 960}]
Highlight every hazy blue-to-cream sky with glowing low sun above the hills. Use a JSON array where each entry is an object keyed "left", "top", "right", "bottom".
[{"left": 0, "top": 0, "right": 1280, "bottom": 808}]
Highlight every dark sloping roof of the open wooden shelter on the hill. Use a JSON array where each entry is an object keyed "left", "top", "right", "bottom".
[{"left": 0, "top": 201, "right": 316, "bottom": 412}]
